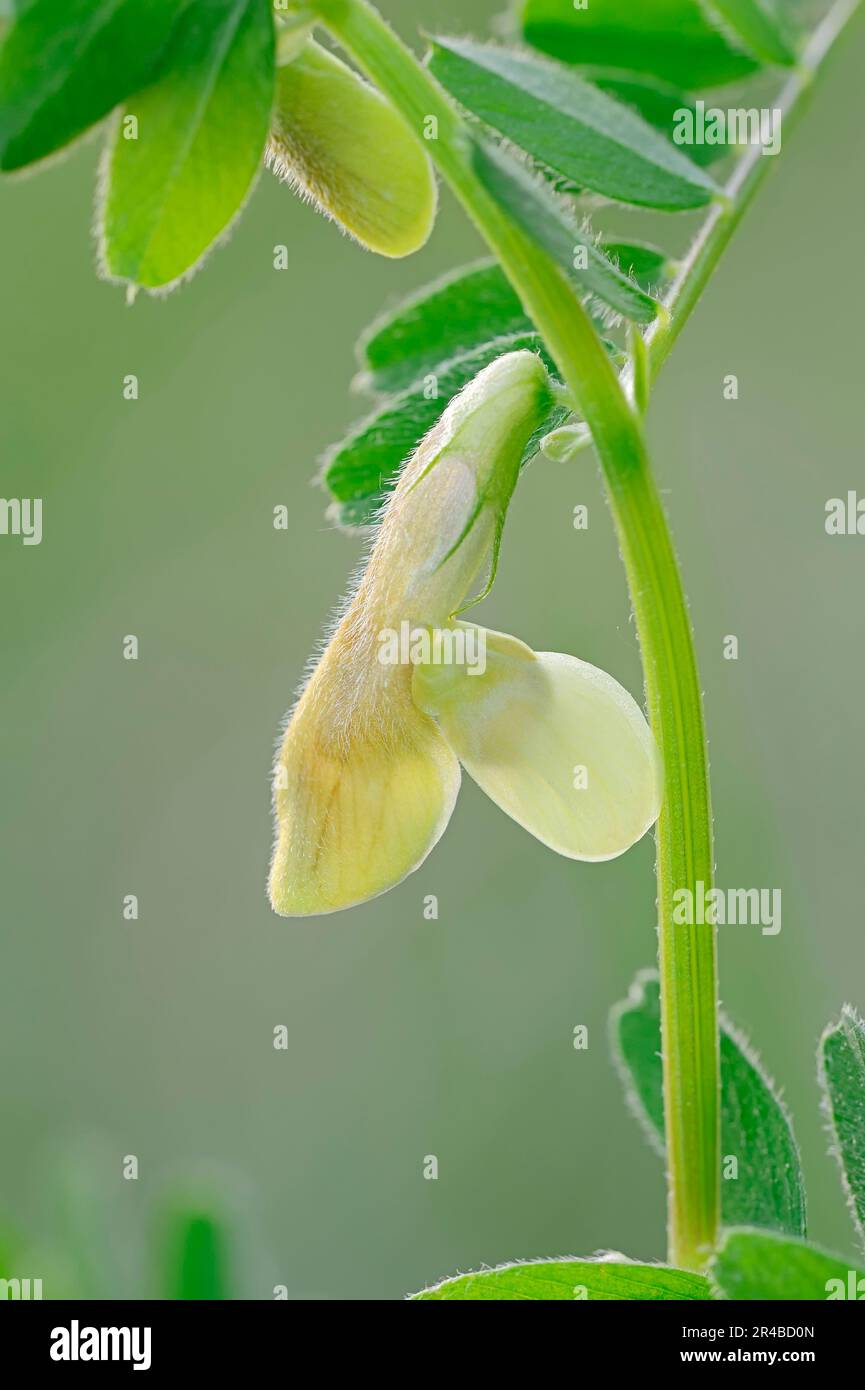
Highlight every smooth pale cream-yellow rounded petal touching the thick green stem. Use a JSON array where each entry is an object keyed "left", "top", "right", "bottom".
[{"left": 413, "top": 632, "right": 661, "bottom": 860}]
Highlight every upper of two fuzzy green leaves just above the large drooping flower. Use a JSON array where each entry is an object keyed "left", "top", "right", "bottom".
[{"left": 359, "top": 261, "right": 534, "bottom": 392}]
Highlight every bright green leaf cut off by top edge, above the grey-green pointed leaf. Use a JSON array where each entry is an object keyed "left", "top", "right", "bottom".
[{"left": 519, "top": 0, "right": 755, "bottom": 90}]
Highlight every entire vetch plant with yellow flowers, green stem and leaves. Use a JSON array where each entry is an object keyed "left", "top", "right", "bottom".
[{"left": 0, "top": 0, "right": 865, "bottom": 1300}]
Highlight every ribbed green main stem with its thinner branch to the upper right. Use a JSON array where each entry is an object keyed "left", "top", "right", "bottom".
[{"left": 313, "top": 0, "right": 858, "bottom": 1268}]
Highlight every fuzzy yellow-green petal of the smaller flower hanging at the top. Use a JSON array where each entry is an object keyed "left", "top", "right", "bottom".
[{"left": 267, "top": 40, "right": 437, "bottom": 256}]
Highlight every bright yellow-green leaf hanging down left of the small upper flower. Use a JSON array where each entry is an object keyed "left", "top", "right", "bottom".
[{"left": 102, "top": 0, "right": 274, "bottom": 289}]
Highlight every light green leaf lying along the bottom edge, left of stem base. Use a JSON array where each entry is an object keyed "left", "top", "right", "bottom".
[{"left": 413, "top": 1259, "right": 712, "bottom": 1302}]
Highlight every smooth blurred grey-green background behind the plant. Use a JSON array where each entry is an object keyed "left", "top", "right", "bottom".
[{"left": 0, "top": 0, "right": 865, "bottom": 1300}]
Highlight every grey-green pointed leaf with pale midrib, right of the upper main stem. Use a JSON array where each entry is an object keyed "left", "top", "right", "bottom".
[{"left": 430, "top": 39, "right": 718, "bottom": 211}]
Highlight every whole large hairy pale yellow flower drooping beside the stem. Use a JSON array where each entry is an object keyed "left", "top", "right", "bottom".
[{"left": 270, "top": 352, "right": 659, "bottom": 916}]
